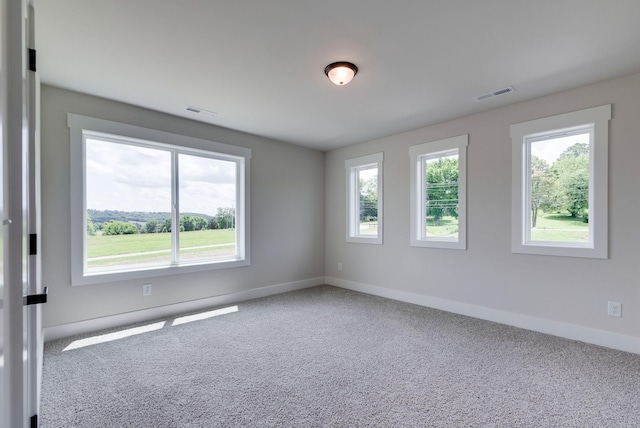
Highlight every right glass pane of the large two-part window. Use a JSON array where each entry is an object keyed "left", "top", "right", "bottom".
[{"left": 178, "top": 154, "right": 237, "bottom": 261}]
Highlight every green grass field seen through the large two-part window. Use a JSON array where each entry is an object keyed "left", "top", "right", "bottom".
[{"left": 87, "top": 229, "right": 235, "bottom": 268}]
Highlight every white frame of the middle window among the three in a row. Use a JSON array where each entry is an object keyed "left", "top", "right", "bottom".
[{"left": 409, "top": 134, "right": 469, "bottom": 250}]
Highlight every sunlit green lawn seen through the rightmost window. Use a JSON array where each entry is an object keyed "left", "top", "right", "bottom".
[{"left": 531, "top": 213, "right": 589, "bottom": 242}]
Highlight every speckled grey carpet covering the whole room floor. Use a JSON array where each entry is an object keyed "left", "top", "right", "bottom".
[{"left": 40, "top": 286, "right": 640, "bottom": 428}]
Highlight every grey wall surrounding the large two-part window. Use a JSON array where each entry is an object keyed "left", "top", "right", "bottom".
[{"left": 41, "top": 86, "right": 325, "bottom": 327}]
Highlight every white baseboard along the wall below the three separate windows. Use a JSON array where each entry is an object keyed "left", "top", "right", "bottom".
[{"left": 325, "top": 276, "right": 640, "bottom": 354}]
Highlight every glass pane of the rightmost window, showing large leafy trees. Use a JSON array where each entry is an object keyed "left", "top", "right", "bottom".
[{"left": 529, "top": 132, "right": 590, "bottom": 243}]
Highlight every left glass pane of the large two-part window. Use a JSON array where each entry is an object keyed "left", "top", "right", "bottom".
[{"left": 85, "top": 138, "right": 171, "bottom": 272}]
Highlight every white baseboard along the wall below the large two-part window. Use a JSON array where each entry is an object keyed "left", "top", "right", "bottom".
[{"left": 44, "top": 277, "right": 325, "bottom": 341}]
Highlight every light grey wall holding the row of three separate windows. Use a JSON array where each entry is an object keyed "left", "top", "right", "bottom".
[{"left": 325, "top": 74, "right": 640, "bottom": 337}]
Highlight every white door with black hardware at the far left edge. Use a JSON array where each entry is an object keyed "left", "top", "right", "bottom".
[{"left": 0, "top": 0, "right": 42, "bottom": 428}]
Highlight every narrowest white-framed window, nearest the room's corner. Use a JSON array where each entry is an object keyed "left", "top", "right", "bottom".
[{"left": 345, "top": 153, "right": 383, "bottom": 244}]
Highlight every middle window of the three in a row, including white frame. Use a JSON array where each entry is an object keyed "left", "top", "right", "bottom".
[{"left": 409, "top": 135, "right": 469, "bottom": 250}]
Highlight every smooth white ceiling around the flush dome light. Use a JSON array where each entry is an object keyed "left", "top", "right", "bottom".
[{"left": 36, "top": 0, "right": 640, "bottom": 150}]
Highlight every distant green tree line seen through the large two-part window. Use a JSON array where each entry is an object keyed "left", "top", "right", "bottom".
[{"left": 87, "top": 208, "right": 236, "bottom": 236}]
